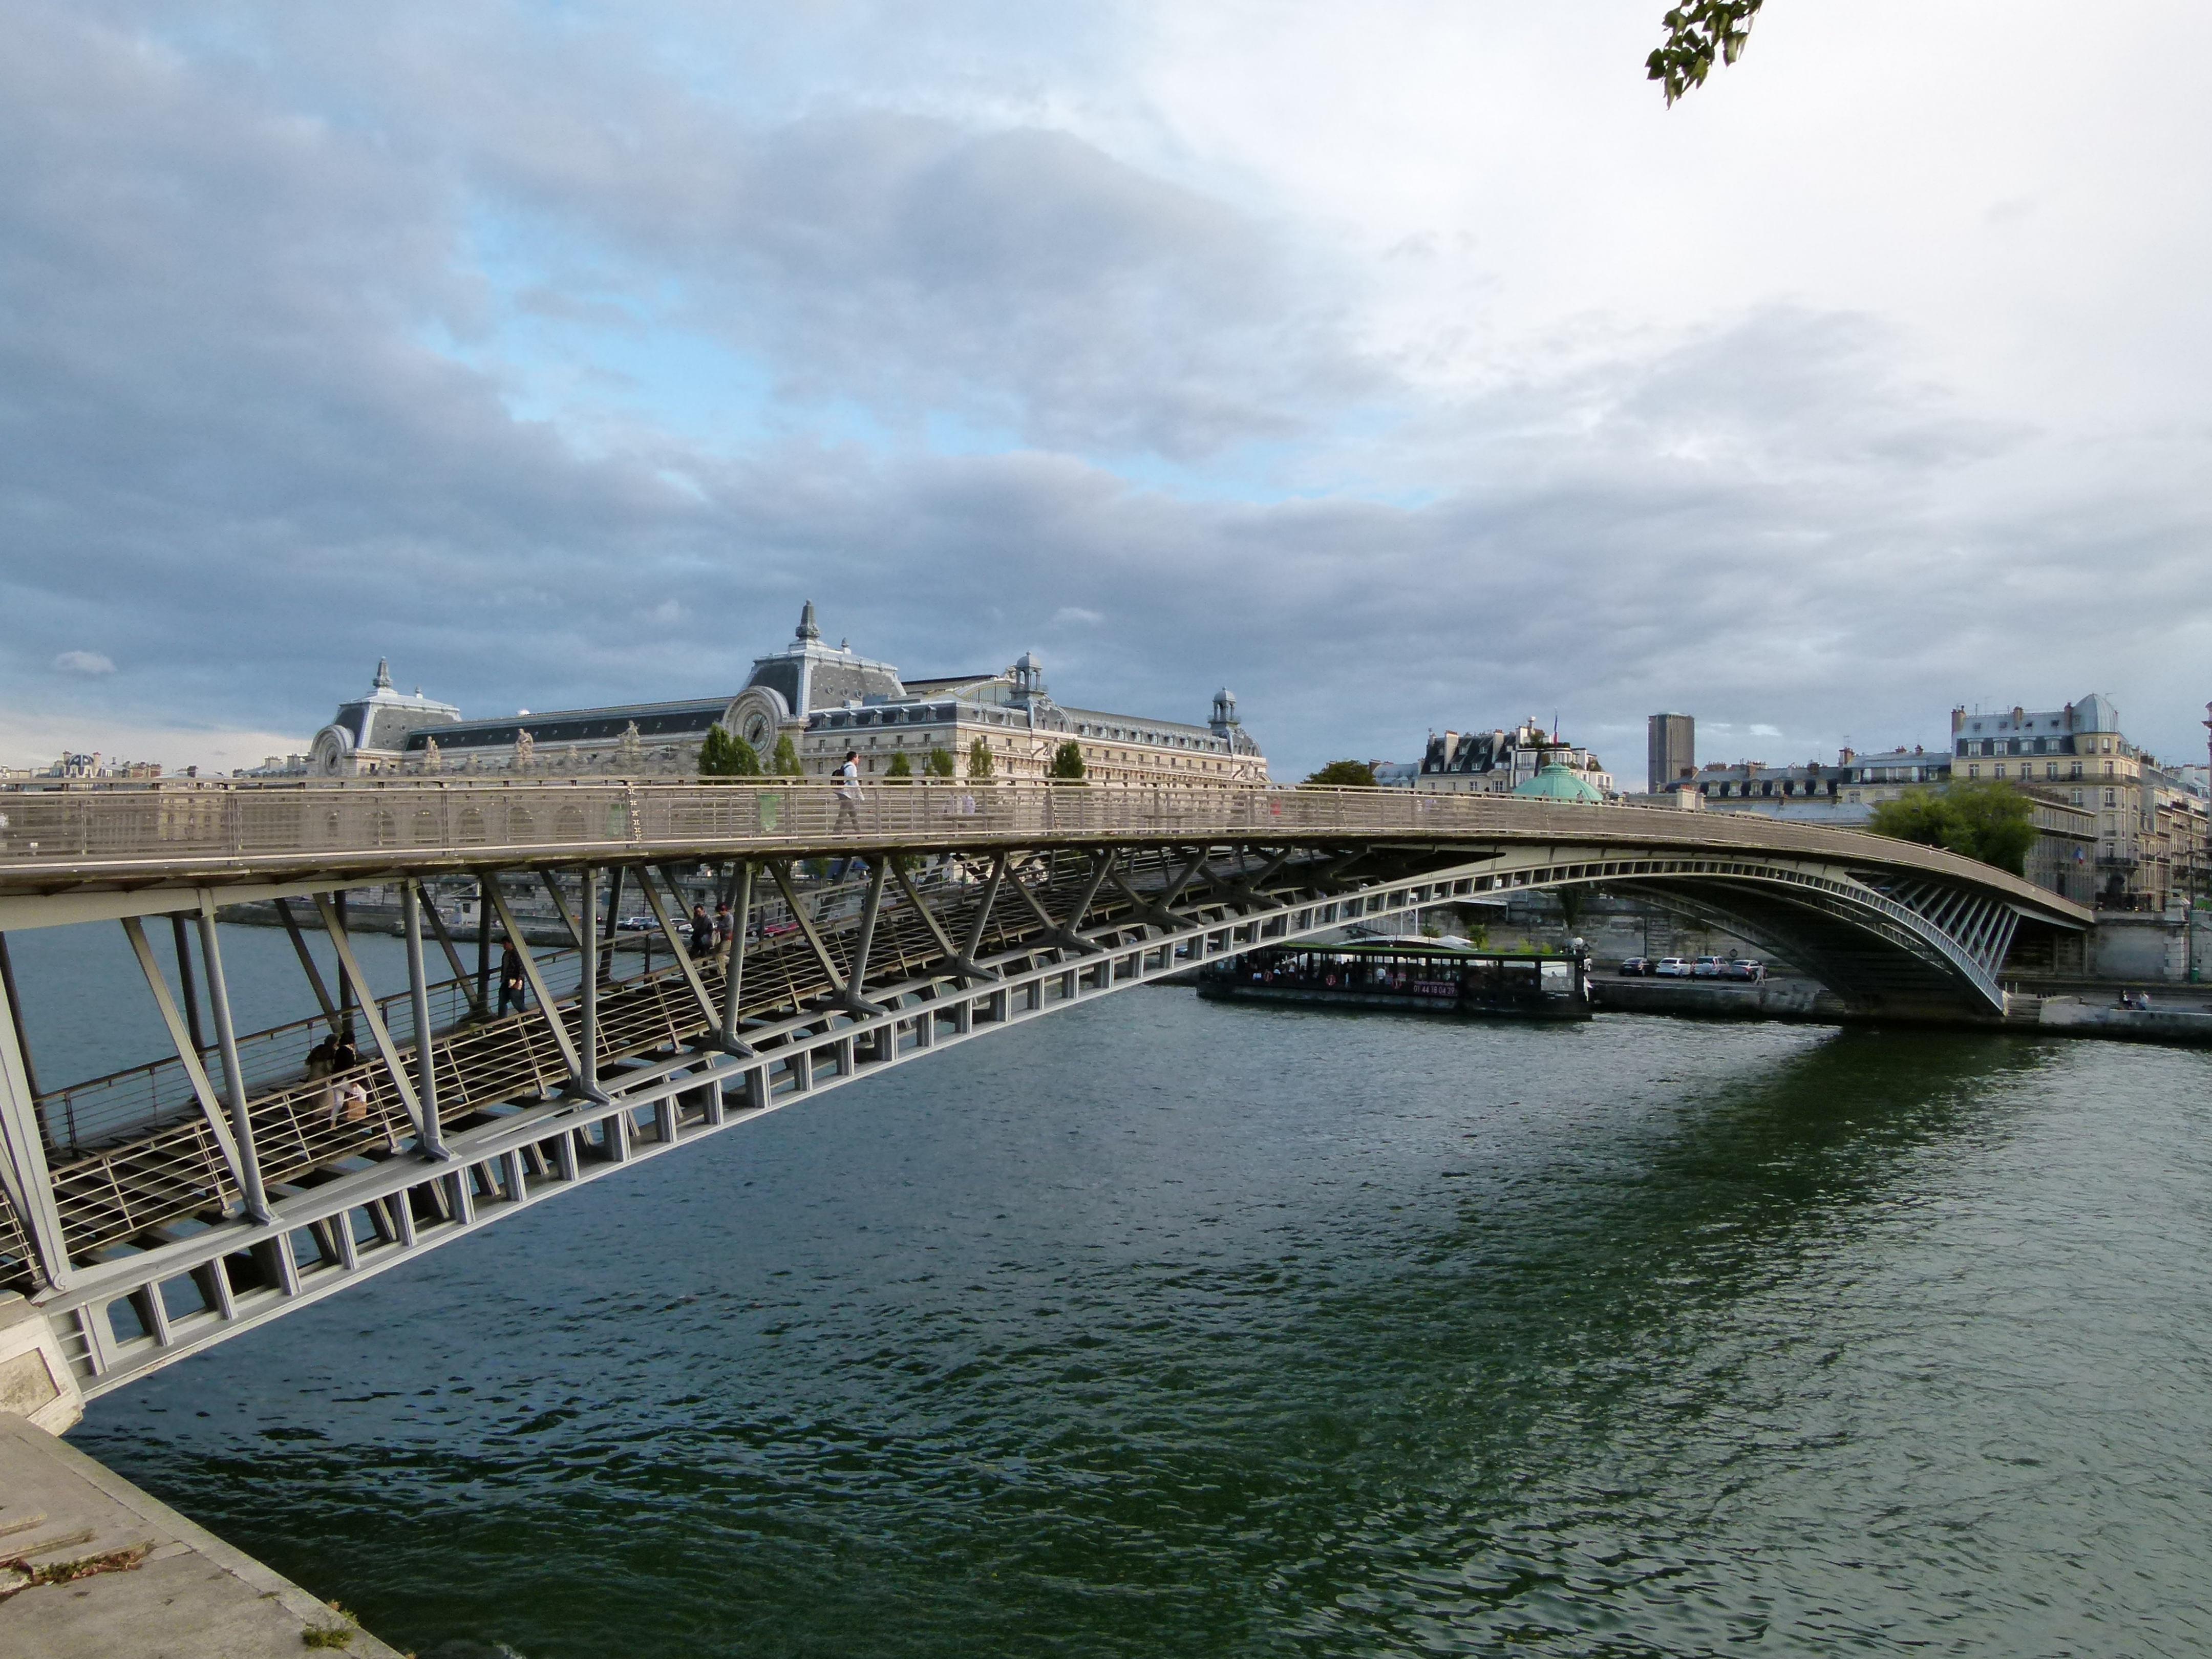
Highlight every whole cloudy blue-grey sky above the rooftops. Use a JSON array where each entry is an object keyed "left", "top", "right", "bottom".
[{"left": 0, "top": 0, "right": 2212, "bottom": 779}]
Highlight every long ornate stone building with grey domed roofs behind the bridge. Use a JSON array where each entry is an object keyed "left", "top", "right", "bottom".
[{"left": 303, "top": 602, "right": 1267, "bottom": 785}]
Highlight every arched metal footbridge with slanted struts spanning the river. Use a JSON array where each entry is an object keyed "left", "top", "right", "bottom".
[{"left": 0, "top": 779, "right": 2090, "bottom": 1396}]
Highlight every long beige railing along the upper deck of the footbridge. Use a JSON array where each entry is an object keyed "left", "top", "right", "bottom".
[{"left": 0, "top": 779, "right": 2073, "bottom": 913}]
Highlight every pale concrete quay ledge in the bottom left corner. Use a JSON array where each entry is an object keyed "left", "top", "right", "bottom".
[{"left": 0, "top": 1416, "right": 400, "bottom": 1659}]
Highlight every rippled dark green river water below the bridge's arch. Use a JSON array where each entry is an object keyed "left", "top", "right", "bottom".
[{"left": 34, "top": 935, "right": 2212, "bottom": 1659}]
